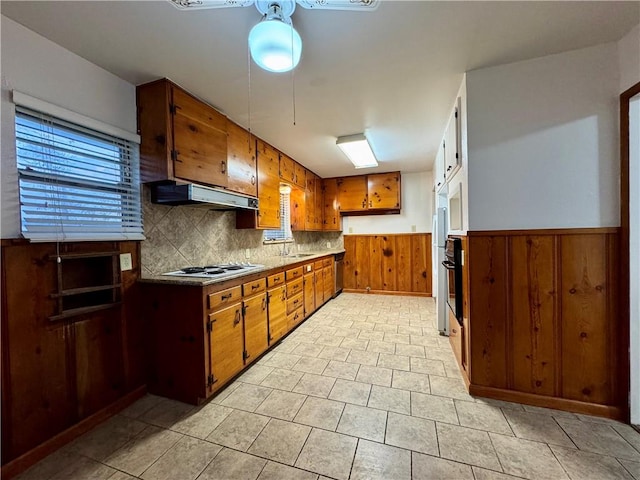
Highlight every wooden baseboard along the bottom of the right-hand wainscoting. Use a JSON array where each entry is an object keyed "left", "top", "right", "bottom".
[{"left": 469, "top": 384, "right": 627, "bottom": 422}]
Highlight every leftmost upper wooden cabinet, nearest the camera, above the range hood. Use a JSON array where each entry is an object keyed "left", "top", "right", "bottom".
[{"left": 137, "top": 79, "right": 228, "bottom": 187}]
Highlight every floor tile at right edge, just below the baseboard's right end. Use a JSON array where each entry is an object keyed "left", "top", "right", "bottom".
[{"left": 556, "top": 417, "right": 640, "bottom": 462}]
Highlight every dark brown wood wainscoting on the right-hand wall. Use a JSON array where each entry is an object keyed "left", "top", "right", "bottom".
[{"left": 465, "top": 228, "right": 629, "bottom": 420}]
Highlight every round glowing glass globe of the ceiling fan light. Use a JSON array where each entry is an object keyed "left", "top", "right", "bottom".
[{"left": 249, "top": 19, "right": 302, "bottom": 73}]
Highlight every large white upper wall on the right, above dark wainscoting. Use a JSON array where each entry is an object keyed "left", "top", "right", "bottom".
[{"left": 467, "top": 43, "right": 620, "bottom": 230}]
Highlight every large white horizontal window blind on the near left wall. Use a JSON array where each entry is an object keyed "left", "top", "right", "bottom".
[{"left": 15, "top": 106, "right": 144, "bottom": 241}]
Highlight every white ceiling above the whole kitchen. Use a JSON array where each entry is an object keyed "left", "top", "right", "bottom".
[{"left": 1, "top": 0, "right": 640, "bottom": 177}]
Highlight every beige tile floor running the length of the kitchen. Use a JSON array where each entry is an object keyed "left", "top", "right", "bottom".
[{"left": 19, "top": 294, "right": 640, "bottom": 480}]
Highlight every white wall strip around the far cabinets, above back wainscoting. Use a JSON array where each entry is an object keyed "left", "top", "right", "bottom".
[{"left": 342, "top": 172, "right": 433, "bottom": 235}]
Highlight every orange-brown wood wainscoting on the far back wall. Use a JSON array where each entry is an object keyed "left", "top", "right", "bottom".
[{"left": 344, "top": 233, "right": 432, "bottom": 296}]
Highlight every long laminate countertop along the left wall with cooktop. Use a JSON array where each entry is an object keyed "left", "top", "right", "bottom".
[{"left": 138, "top": 248, "right": 345, "bottom": 287}]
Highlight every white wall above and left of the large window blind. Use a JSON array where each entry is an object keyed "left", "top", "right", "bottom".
[{"left": 0, "top": 16, "right": 136, "bottom": 238}]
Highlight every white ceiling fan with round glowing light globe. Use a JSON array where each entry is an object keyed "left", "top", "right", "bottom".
[{"left": 169, "top": 0, "right": 380, "bottom": 73}]
